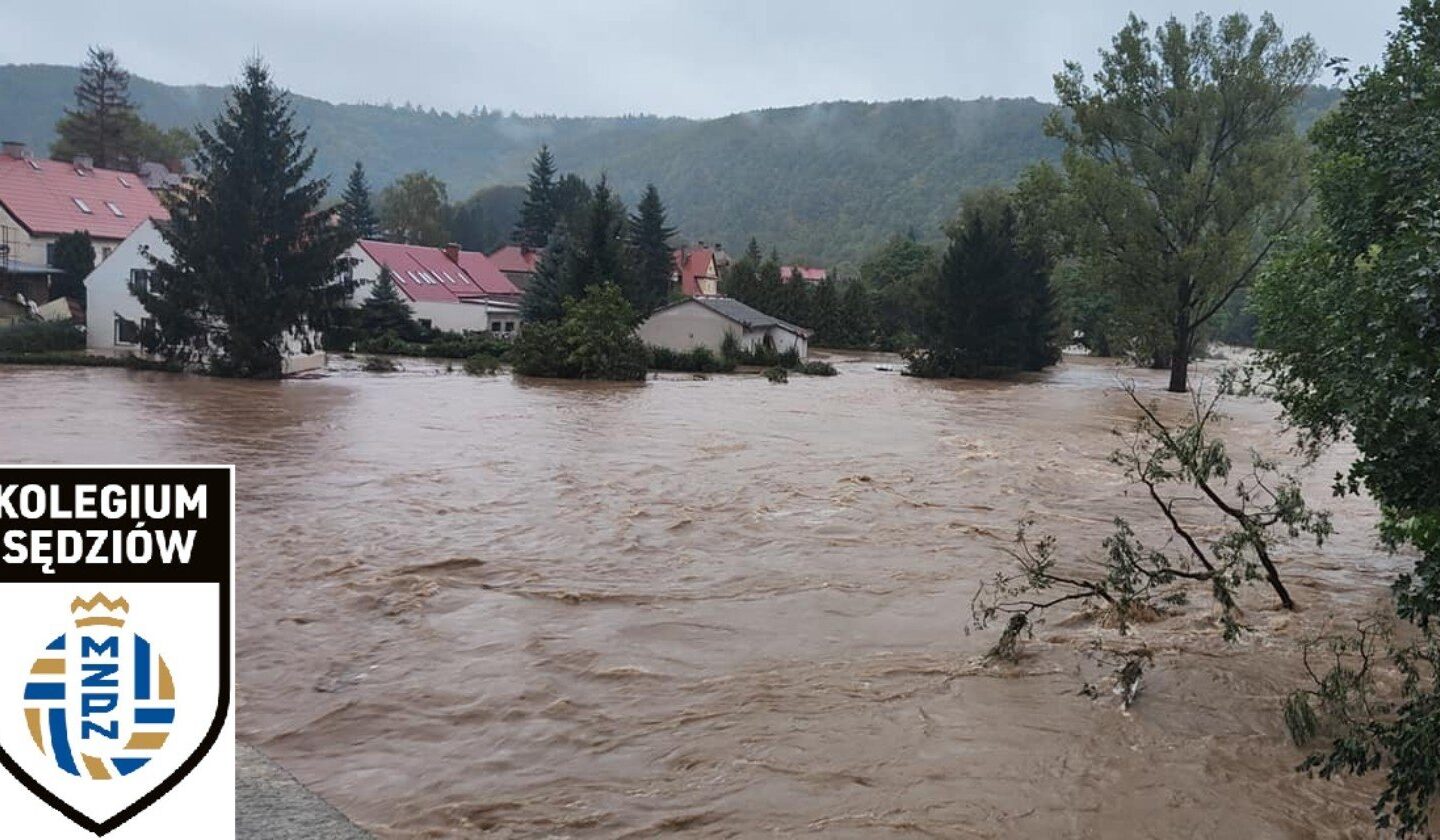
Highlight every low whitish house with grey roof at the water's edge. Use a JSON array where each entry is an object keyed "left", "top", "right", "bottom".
[{"left": 639, "top": 295, "right": 811, "bottom": 359}]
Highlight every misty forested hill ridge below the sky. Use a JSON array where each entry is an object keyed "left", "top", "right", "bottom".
[{"left": 0, "top": 65, "right": 1339, "bottom": 267}]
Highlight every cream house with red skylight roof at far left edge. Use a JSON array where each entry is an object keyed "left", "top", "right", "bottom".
[{"left": 0, "top": 143, "right": 170, "bottom": 303}]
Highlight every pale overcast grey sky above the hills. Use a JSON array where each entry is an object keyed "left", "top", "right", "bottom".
[{"left": 0, "top": 0, "right": 1401, "bottom": 117}]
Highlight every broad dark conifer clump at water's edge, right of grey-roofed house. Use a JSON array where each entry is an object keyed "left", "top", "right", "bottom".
[{"left": 906, "top": 190, "right": 1060, "bottom": 376}]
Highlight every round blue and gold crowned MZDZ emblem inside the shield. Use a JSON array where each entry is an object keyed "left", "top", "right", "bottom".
[{"left": 24, "top": 594, "right": 176, "bottom": 781}]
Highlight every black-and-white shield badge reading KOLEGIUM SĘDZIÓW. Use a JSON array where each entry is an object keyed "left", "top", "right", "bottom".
[{"left": 0, "top": 467, "right": 235, "bottom": 836}]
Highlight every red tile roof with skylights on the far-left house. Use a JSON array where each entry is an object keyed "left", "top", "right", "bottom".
[{"left": 0, "top": 156, "right": 170, "bottom": 239}]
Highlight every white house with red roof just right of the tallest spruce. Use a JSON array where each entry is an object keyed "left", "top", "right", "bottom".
[{"left": 348, "top": 239, "right": 521, "bottom": 336}]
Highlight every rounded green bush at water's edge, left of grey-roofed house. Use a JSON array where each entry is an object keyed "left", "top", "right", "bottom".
[{"left": 510, "top": 282, "right": 647, "bottom": 380}]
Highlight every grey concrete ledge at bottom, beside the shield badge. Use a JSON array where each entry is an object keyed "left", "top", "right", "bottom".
[{"left": 235, "top": 743, "right": 370, "bottom": 840}]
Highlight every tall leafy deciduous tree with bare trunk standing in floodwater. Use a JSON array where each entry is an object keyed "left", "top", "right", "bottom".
[{"left": 1047, "top": 14, "right": 1320, "bottom": 390}]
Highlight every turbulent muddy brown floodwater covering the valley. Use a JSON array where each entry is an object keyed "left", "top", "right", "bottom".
[{"left": 0, "top": 360, "right": 1392, "bottom": 839}]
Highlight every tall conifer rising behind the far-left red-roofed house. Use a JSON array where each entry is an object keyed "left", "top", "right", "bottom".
[{"left": 50, "top": 46, "right": 140, "bottom": 169}]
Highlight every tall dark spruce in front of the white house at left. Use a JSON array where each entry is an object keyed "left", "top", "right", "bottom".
[{"left": 131, "top": 61, "right": 351, "bottom": 377}]
